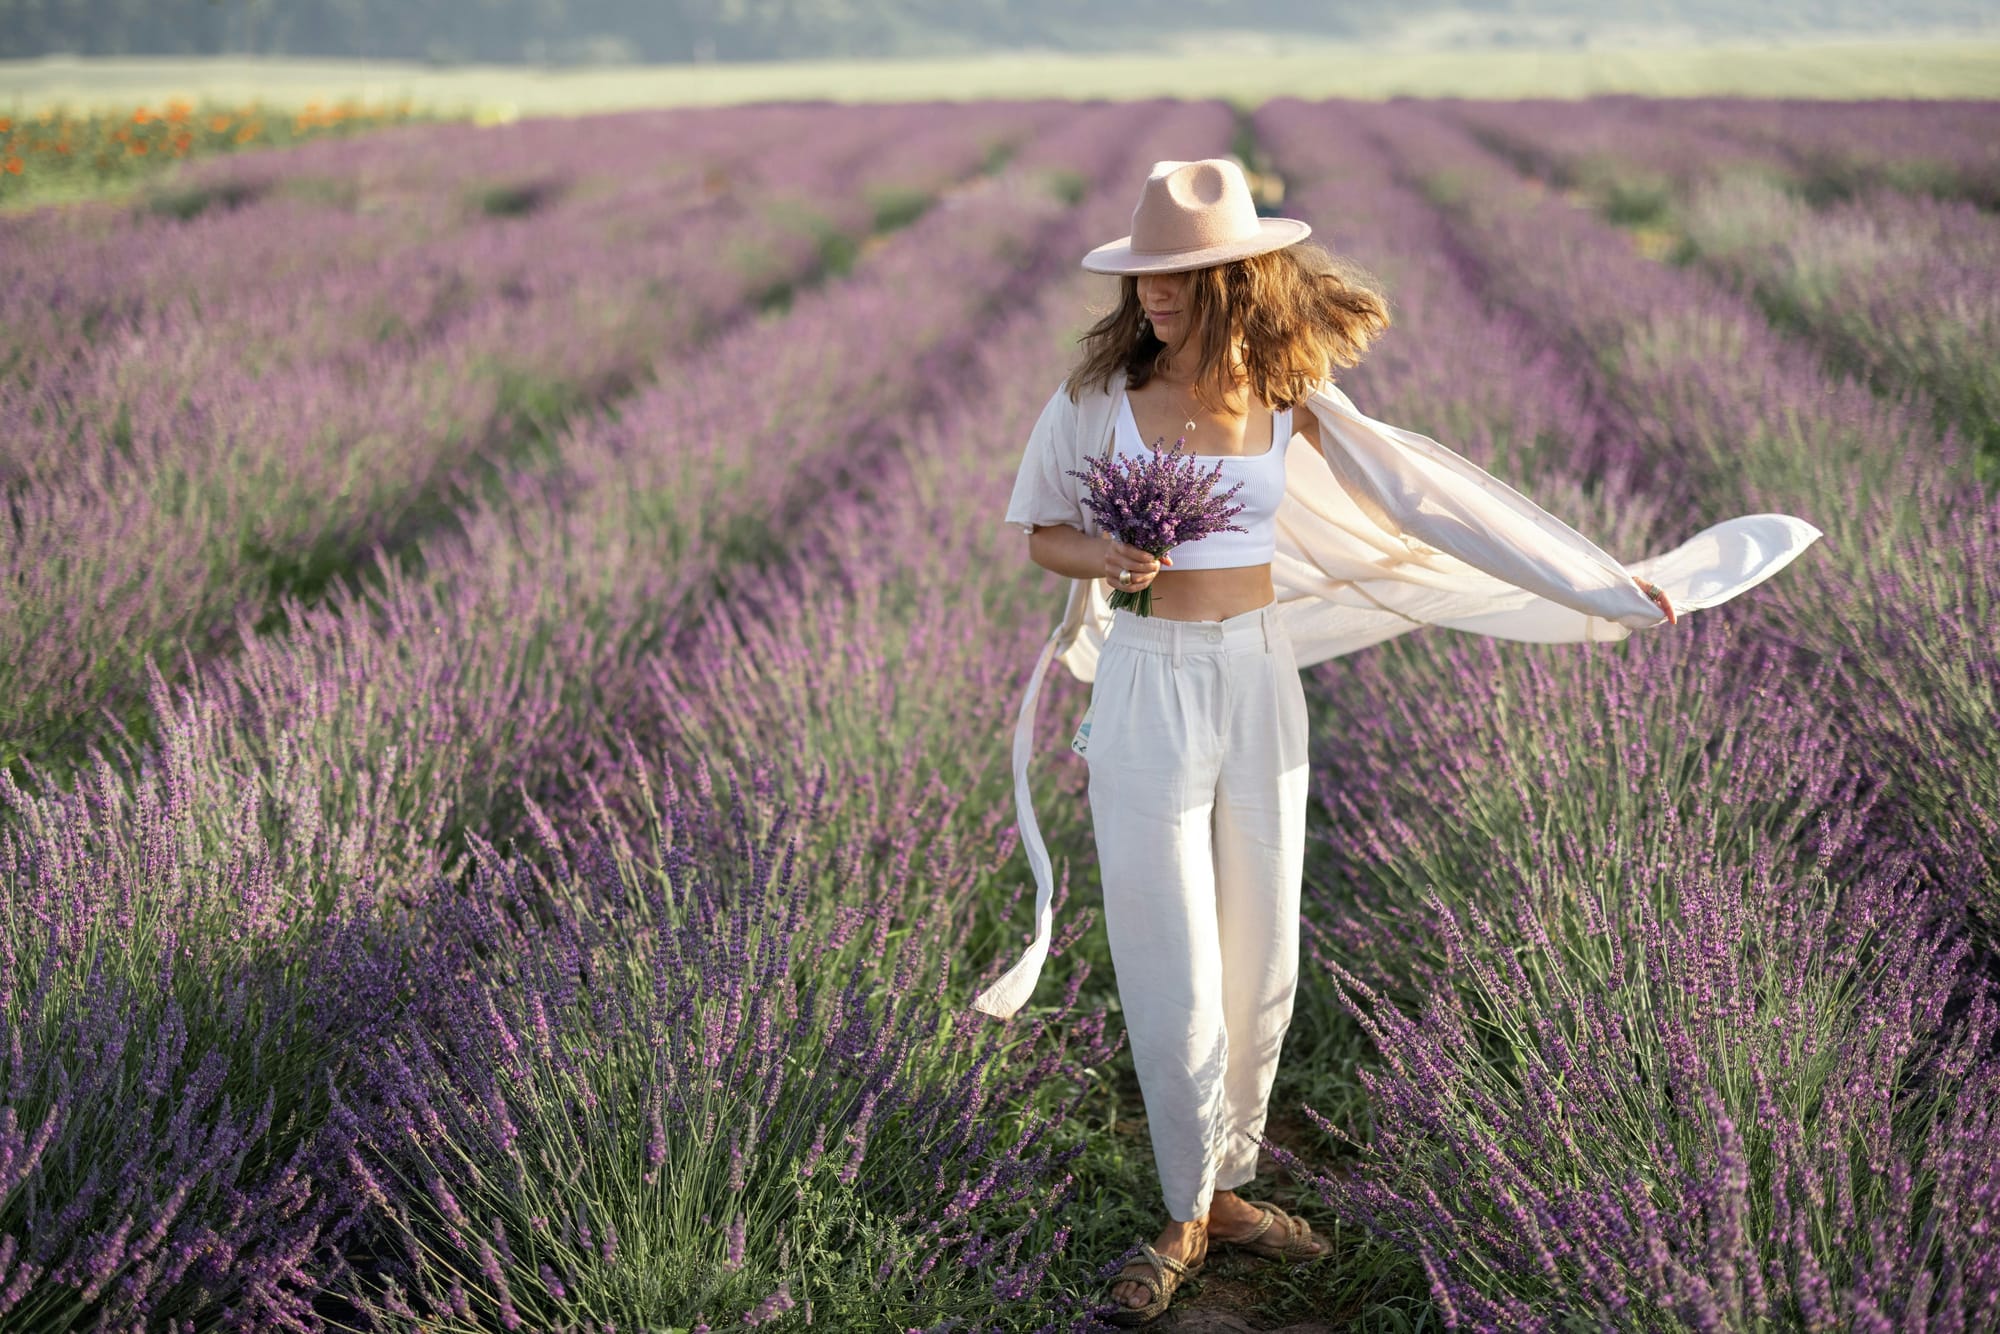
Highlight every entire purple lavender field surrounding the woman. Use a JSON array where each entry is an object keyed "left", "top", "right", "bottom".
[{"left": 0, "top": 98, "right": 2000, "bottom": 1334}]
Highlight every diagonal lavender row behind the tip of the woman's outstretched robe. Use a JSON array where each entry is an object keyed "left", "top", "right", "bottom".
[{"left": 1376, "top": 104, "right": 2000, "bottom": 960}]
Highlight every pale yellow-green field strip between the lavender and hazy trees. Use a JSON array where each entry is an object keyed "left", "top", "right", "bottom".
[{"left": 0, "top": 40, "right": 2000, "bottom": 118}]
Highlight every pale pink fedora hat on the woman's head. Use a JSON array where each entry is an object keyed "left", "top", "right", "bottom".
[{"left": 1084, "top": 158, "right": 1312, "bottom": 274}]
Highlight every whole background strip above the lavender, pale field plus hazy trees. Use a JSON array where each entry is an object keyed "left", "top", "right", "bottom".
[{"left": 0, "top": 0, "right": 2000, "bottom": 122}]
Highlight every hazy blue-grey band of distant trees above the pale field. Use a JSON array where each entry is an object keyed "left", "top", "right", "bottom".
[{"left": 0, "top": 0, "right": 2000, "bottom": 66}]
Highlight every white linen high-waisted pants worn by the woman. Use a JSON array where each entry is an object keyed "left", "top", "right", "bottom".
[{"left": 1084, "top": 606, "right": 1306, "bottom": 1222}]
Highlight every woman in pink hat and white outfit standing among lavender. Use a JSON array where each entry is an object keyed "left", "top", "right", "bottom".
[{"left": 974, "top": 158, "right": 1820, "bottom": 1324}]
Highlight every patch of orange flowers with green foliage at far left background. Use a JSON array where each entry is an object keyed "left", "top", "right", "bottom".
[{"left": 0, "top": 98, "right": 430, "bottom": 208}]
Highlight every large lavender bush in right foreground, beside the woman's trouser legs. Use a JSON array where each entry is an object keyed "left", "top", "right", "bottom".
[{"left": 1288, "top": 618, "right": 2000, "bottom": 1330}]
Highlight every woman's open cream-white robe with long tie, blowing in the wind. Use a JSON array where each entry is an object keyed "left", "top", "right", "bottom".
[{"left": 972, "top": 382, "right": 1820, "bottom": 1018}]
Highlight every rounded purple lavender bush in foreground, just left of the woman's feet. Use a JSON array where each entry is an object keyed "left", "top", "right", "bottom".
[{"left": 328, "top": 770, "right": 1102, "bottom": 1328}]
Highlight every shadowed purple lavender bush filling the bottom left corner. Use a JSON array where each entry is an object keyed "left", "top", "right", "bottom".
[{"left": 0, "top": 736, "right": 412, "bottom": 1330}]
